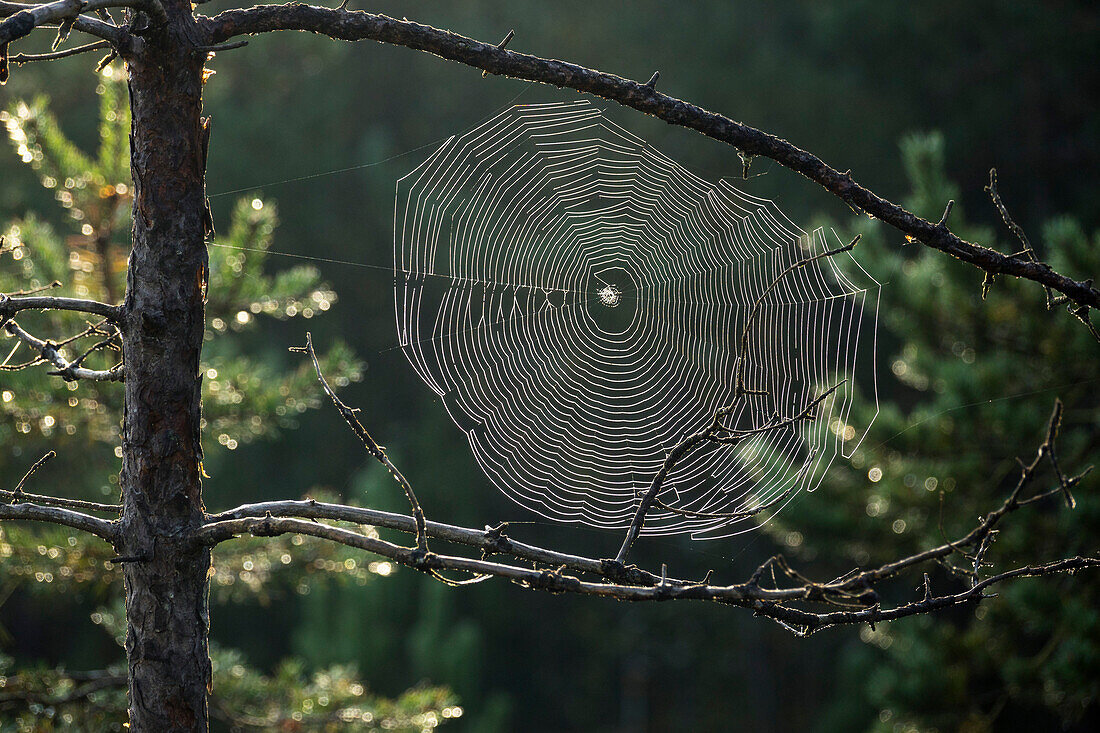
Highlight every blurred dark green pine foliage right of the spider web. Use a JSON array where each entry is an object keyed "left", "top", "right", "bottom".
[{"left": 767, "top": 134, "right": 1100, "bottom": 733}]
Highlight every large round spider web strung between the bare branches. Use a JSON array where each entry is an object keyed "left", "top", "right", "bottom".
[{"left": 394, "top": 101, "right": 879, "bottom": 538}]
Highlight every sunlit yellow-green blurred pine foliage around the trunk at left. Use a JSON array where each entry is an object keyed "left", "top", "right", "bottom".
[{"left": 0, "top": 66, "right": 462, "bottom": 733}]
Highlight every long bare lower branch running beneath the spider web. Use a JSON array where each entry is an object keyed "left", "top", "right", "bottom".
[{"left": 193, "top": 341, "right": 1100, "bottom": 635}]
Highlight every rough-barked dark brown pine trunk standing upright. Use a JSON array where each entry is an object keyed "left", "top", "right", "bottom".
[{"left": 120, "top": 0, "right": 211, "bottom": 733}]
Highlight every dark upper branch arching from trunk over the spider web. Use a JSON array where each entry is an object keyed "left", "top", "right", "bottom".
[{"left": 199, "top": 3, "right": 1100, "bottom": 308}]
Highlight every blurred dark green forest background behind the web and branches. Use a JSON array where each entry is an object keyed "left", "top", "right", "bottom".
[{"left": 0, "top": 0, "right": 1100, "bottom": 733}]
